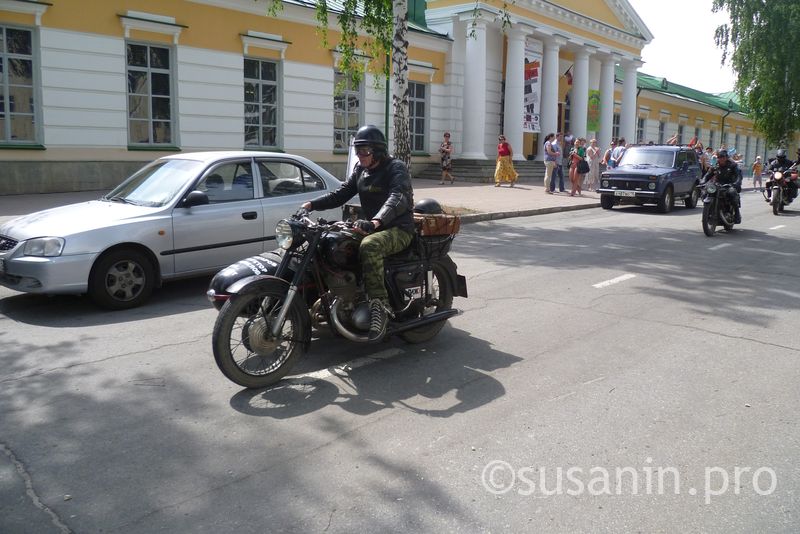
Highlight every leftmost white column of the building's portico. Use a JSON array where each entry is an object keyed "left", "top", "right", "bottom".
[{"left": 461, "top": 19, "right": 487, "bottom": 159}]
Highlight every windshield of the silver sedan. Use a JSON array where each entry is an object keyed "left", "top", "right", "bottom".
[{"left": 103, "top": 159, "right": 204, "bottom": 208}]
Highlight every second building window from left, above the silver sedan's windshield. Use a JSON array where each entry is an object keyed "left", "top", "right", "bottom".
[{"left": 127, "top": 43, "right": 175, "bottom": 145}]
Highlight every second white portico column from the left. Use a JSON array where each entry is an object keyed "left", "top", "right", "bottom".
[{"left": 503, "top": 29, "right": 526, "bottom": 160}]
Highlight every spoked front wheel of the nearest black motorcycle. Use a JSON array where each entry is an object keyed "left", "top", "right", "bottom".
[{"left": 212, "top": 287, "right": 304, "bottom": 388}]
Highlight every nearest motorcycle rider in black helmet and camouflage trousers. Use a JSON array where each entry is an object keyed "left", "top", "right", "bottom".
[{"left": 302, "top": 125, "right": 414, "bottom": 341}]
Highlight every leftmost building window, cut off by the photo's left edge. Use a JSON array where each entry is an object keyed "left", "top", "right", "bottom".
[{"left": 0, "top": 26, "right": 37, "bottom": 144}]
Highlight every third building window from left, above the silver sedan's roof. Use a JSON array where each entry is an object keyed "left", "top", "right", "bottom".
[{"left": 244, "top": 58, "right": 280, "bottom": 148}]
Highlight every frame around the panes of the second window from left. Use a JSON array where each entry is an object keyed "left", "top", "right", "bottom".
[{"left": 125, "top": 39, "right": 180, "bottom": 150}]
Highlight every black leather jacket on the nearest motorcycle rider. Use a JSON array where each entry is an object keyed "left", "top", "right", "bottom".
[{"left": 311, "top": 157, "right": 414, "bottom": 232}]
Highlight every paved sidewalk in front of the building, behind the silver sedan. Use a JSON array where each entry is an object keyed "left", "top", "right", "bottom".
[{"left": 0, "top": 179, "right": 600, "bottom": 223}]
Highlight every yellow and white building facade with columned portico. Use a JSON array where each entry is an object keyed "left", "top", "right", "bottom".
[{"left": 0, "top": 0, "right": 776, "bottom": 194}]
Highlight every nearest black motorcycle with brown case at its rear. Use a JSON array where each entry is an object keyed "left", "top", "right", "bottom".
[{"left": 207, "top": 205, "right": 467, "bottom": 388}]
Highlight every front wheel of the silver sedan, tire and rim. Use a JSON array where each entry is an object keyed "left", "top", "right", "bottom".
[{"left": 89, "top": 248, "right": 155, "bottom": 310}]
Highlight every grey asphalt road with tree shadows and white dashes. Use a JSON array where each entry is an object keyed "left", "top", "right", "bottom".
[{"left": 0, "top": 193, "right": 800, "bottom": 533}]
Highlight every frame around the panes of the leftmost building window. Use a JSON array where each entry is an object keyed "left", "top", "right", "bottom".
[{"left": 0, "top": 21, "right": 44, "bottom": 148}]
